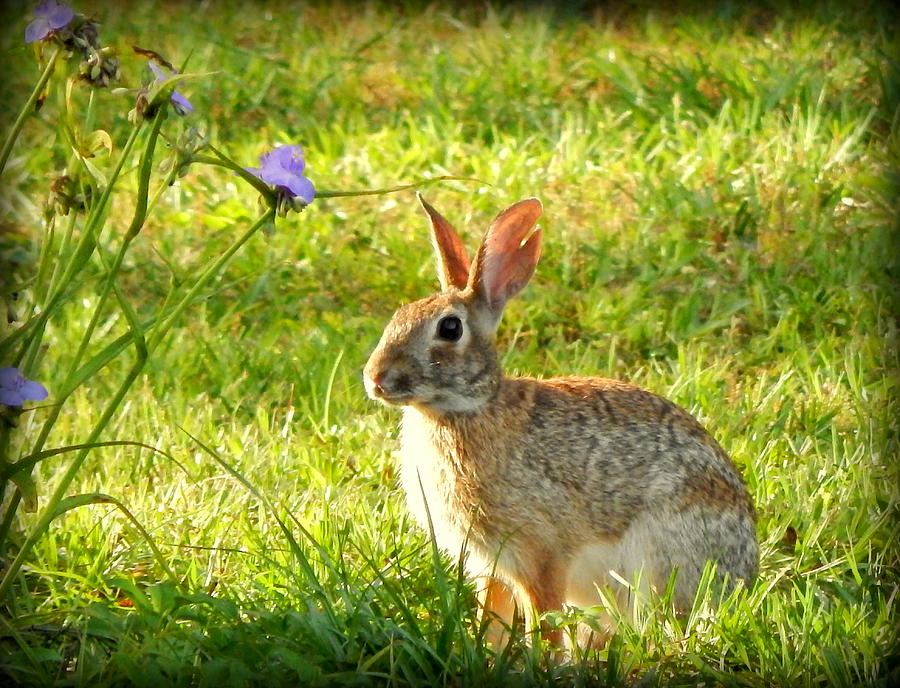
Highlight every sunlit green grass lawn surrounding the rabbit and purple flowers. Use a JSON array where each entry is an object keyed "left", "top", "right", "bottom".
[{"left": 0, "top": 2, "right": 900, "bottom": 686}]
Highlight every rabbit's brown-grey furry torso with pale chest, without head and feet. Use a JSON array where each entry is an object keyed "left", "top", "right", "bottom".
[{"left": 401, "top": 377, "right": 756, "bottom": 604}]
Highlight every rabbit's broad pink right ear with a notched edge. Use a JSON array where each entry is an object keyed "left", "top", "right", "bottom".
[{"left": 469, "top": 198, "right": 542, "bottom": 321}]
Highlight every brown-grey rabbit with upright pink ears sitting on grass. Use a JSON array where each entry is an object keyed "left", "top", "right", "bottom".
[{"left": 363, "top": 195, "right": 759, "bottom": 647}]
